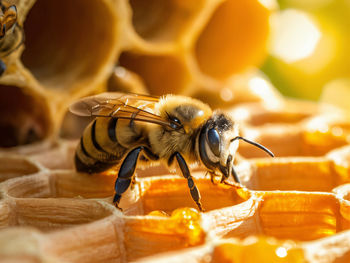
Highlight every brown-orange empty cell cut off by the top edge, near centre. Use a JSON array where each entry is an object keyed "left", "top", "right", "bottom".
[{"left": 130, "top": 0, "right": 205, "bottom": 43}]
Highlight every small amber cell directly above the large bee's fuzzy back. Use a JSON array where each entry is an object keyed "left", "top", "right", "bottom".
[{"left": 119, "top": 52, "right": 191, "bottom": 95}]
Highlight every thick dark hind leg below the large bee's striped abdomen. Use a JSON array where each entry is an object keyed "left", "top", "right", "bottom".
[{"left": 113, "top": 146, "right": 158, "bottom": 208}]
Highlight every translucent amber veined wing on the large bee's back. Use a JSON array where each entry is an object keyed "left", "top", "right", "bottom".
[{"left": 69, "top": 92, "right": 178, "bottom": 128}]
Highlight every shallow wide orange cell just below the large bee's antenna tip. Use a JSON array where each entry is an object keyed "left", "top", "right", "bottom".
[{"left": 241, "top": 157, "right": 344, "bottom": 192}]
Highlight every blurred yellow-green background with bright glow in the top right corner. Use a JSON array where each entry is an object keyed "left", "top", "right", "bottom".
[{"left": 261, "top": 0, "right": 350, "bottom": 103}]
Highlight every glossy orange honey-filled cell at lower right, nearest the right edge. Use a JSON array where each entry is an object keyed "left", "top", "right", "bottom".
[{"left": 259, "top": 192, "right": 349, "bottom": 241}]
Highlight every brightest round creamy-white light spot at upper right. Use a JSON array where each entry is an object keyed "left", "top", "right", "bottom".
[{"left": 271, "top": 9, "right": 321, "bottom": 63}]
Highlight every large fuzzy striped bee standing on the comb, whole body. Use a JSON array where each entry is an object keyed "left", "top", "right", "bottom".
[{"left": 70, "top": 92, "right": 273, "bottom": 211}]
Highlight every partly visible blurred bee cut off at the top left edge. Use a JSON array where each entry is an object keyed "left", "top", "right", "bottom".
[{"left": 0, "top": 1, "right": 24, "bottom": 76}]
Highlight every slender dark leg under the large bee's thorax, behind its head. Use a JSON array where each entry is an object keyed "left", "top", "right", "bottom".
[{"left": 168, "top": 152, "right": 204, "bottom": 212}]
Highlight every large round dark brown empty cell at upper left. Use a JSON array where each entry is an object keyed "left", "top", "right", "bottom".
[{"left": 22, "top": 0, "right": 119, "bottom": 92}]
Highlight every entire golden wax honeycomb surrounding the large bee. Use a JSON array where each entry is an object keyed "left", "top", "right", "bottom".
[{"left": 0, "top": 0, "right": 350, "bottom": 263}]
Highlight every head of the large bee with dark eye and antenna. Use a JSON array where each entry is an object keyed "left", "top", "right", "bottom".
[{"left": 198, "top": 112, "right": 273, "bottom": 184}]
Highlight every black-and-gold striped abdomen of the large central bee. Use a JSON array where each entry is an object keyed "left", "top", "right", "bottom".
[{"left": 75, "top": 117, "right": 144, "bottom": 173}]
